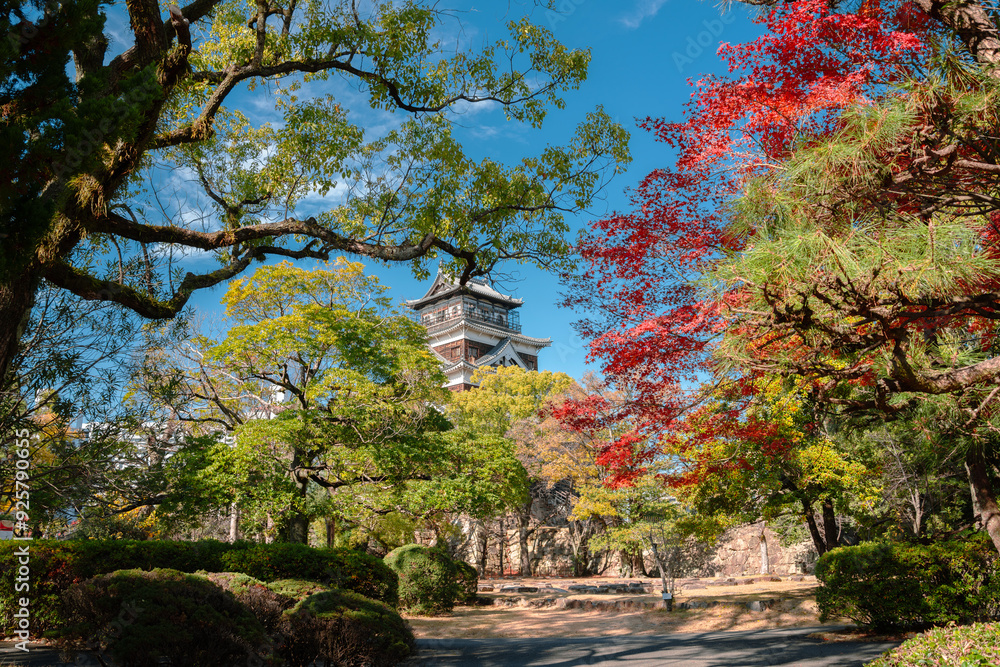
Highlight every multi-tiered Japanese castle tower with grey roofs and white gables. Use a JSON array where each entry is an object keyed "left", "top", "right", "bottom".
[{"left": 406, "top": 270, "right": 552, "bottom": 391}]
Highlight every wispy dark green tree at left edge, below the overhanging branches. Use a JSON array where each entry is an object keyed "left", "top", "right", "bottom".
[{"left": 0, "top": 283, "right": 185, "bottom": 536}]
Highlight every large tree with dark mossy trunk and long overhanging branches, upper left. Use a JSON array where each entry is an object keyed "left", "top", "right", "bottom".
[{"left": 0, "top": 0, "right": 628, "bottom": 386}]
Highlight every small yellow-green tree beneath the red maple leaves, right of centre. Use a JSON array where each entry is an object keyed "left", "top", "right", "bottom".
[{"left": 665, "top": 378, "right": 882, "bottom": 555}]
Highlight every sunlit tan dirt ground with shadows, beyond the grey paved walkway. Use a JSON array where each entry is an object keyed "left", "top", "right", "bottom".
[{"left": 406, "top": 578, "right": 837, "bottom": 639}]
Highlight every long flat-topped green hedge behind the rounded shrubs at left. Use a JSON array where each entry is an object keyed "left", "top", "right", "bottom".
[{"left": 0, "top": 540, "right": 398, "bottom": 635}]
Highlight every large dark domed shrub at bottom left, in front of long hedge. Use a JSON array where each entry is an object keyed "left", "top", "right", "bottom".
[{"left": 63, "top": 569, "right": 276, "bottom": 667}]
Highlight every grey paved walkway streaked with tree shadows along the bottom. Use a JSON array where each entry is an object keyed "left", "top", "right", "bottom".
[{"left": 404, "top": 628, "right": 896, "bottom": 667}]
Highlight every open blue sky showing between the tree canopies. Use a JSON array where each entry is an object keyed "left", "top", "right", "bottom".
[{"left": 182, "top": 0, "right": 761, "bottom": 378}]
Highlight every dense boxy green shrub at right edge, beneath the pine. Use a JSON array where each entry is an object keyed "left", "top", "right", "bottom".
[{"left": 816, "top": 533, "right": 1000, "bottom": 631}]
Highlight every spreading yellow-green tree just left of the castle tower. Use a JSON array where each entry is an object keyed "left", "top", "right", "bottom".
[{"left": 147, "top": 260, "right": 525, "bottom": 541}]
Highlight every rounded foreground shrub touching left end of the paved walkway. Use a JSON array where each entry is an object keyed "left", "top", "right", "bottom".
[{"left": 283, "top": 590, "right": 414, "bottom": 667}]
